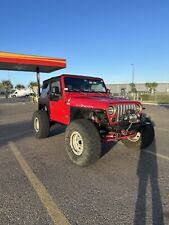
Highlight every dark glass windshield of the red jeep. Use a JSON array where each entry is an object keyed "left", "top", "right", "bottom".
[{"left": 64, "top": 77, "right": 106, "bottom": 93}]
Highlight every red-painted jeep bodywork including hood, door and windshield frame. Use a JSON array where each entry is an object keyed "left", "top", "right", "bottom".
[{"left": 50, "top": 75, "right": 140, "bottom": 125}]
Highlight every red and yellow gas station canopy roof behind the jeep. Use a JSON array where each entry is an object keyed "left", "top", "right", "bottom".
[{"left": 0, "top": 52, "right": 66, "bottom": 73}]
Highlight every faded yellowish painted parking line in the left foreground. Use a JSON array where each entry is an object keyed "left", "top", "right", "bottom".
[{"left": 8, "top": 142, "right": 70, "bottom": 225}]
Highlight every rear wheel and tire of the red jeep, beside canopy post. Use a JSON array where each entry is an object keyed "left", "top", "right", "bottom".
[{"left": 32, "top": 110, "right": 50, "bottom": 138}]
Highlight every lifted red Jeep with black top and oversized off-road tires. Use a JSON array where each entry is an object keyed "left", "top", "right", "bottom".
[{"left": 33, "top": 75, "right": 154, "bottom": 166}]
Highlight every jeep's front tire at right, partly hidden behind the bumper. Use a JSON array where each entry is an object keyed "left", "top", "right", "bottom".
[{"left": 122, "top": 118, "right": 154, "bottom": 150}]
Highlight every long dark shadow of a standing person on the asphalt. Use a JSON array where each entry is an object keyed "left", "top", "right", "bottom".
[{"left": 133, "top": 140, "right": 164, "bottom": 225}]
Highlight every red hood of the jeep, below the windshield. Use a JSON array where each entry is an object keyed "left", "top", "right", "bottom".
[{"left": 69, "top": 96, "right": 140, "bottom": 109}]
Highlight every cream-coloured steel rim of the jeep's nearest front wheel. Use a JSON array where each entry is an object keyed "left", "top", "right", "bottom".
[{"left": 70, "top": 131, "right": 83, "bottom": 156}]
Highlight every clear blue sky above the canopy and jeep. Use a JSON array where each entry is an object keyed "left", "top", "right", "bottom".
[{"left": 0, "top": 0, "right": 169, "bottom": 86}]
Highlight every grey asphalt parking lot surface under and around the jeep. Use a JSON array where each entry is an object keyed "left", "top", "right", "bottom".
[{"left": 0, "top": 102, "right": 169, "bottom": 225}]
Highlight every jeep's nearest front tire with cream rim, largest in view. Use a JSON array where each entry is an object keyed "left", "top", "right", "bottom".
[{"left": 65, "top": 119, "right": 101, "bottom": 166}]
